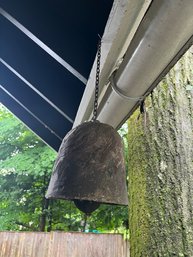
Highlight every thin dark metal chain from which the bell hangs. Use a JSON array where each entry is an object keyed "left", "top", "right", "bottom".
[{"left": 92, "top": 40, "right": 101, "bottom": 121}]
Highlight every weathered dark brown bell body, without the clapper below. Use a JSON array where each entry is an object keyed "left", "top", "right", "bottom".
[{"left": 46, "top": 121, "right": 128, "bottom": 205}]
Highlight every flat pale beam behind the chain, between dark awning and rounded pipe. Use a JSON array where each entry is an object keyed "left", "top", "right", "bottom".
[{"left": 73, "top": 0, "right": 152, "bottom": 127}]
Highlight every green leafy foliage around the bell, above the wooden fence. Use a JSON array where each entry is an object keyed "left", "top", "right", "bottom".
[{"left": 0, "top": 105, "right": 128, "bottom": 232}]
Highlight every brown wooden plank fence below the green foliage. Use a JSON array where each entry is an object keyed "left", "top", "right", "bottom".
[{"left": 0, "top": 232, "right": 128, "bottom": 257}]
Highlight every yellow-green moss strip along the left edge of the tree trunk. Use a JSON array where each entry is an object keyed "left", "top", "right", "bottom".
[{"left": 128, "top": 112, "right": 149, "bottom": 257}]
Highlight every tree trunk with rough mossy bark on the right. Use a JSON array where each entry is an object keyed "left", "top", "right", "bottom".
[{"left": 128, "top": 47, "right": 193, "bottom": 254}]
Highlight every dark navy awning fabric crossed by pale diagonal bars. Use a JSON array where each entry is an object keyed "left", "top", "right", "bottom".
[{"left": 0, "top": 0, "right": 113, "bottom": 150}]
